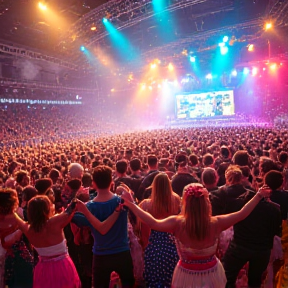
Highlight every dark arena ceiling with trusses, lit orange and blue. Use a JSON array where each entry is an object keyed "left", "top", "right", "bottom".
[{"left": 0, "top": 0, "right": 288, "bottom": 76}]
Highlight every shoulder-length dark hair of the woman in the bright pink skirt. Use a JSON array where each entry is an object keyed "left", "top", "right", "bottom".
[{"left": 28, "top": 195, "right": 51, "bottom": 232}]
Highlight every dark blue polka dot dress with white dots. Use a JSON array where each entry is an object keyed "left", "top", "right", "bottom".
[{"left": 144, "top": 230, "right": 179, "bottom": 288}]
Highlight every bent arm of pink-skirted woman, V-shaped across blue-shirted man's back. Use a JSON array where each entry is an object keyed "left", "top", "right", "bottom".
[{"left": 77, "top": 201, "right": 121, "bottom": 235}]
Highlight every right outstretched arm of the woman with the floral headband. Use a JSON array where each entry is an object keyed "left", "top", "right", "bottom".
[{"left": 216, "top": 186, "right": 271, "bottom": 232}]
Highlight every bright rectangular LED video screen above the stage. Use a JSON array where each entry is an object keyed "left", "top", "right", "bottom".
[{"left": 176, "top": 90, "right": 235, "bottom": 119}]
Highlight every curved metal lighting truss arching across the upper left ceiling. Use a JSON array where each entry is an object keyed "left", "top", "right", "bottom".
[{"left": 59, "top": 0, "right": 233, "bottom": 48}]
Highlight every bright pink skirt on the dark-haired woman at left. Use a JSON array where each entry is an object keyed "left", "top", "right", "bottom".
[{"left": 33, "top": 254, "right": 81, "bottom": 288}]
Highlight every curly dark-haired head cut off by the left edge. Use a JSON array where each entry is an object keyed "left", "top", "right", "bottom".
[{"left": 0, "top": 188, "right": 19, "bottom": 215}]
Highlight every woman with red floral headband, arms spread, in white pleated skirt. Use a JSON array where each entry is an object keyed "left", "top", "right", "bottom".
[{"left": 122, "top": 183, "right": 270, "bottom": 288}]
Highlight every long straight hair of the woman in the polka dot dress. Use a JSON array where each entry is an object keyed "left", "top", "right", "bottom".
[{"left": 151, "top": 173, "right": 174, "bottom": 217}]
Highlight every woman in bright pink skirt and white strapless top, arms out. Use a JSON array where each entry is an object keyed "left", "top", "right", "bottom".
[{"left": 15, "top": 195, "right": 119, "bottom": 288}]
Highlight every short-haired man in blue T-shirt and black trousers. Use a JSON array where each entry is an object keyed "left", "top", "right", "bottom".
[{"left": 72, "top": 165, "right": 135, "bottom": 288}]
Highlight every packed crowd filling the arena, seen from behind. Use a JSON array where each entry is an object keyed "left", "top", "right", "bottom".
[{"left": 0, "top": 122, "right": 288, "bottom": 288}]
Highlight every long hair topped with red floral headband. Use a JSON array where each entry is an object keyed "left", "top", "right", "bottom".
[{"left": 183, "top": 183, "right": 212, "bottom": 241}]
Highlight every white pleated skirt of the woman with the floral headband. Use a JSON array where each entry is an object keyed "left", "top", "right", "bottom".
[{"left": 171, "top": 259, "right": 227, "bottom": 288}]
